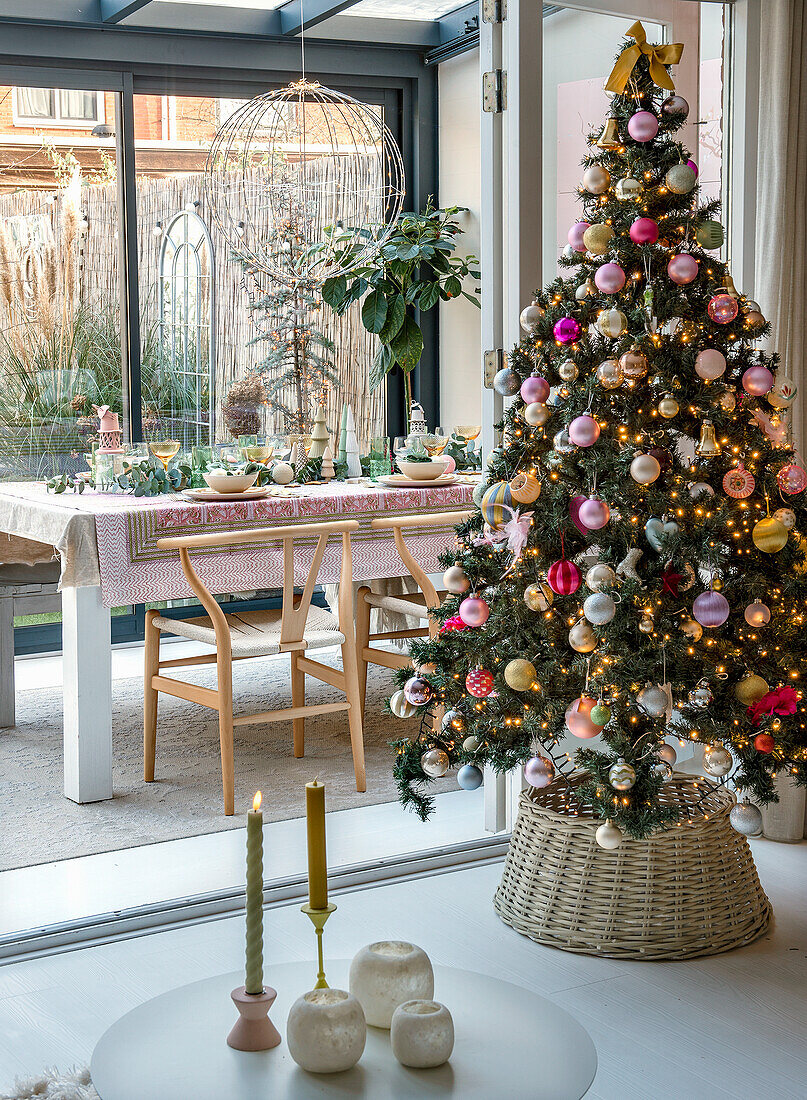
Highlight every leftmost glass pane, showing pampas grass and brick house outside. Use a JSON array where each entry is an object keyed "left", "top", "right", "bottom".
[{"left": 0, "top": 88, "right": 122, "bottom": 481}]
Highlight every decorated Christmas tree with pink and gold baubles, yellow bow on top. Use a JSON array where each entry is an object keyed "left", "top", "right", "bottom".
[{"left": 390, "top": 24, "right": 807, "bottom": 847}]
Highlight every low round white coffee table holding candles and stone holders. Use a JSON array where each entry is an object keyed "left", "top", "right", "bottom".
[{"left": 90, "top": 960, "right": 597, "bottom": 1100}]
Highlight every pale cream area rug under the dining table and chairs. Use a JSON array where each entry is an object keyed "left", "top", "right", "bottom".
[{"left": 0, "top": 651, "right": 417, "bottom": 870}]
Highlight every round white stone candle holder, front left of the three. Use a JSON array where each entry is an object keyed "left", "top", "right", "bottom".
[{"left": 286, "top": 989, "right": 367, "bottom": 1074}]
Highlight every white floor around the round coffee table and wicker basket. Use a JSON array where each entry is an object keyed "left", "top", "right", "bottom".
[{"left": 0, "top": 840, "right": 807, "bottom": 1100}]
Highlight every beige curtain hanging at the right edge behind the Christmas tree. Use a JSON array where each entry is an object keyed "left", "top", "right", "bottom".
[{"left": 754, "top": 0, "right": 807, "bottom": 457}]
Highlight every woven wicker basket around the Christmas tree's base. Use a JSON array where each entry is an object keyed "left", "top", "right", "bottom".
[{"left": 494, "top": 776, "right": 772, "bottom": 959}]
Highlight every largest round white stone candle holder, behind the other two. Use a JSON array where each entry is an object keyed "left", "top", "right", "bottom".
[{"left": 350, "top": 939, "right": 434, "bottom": 1027}]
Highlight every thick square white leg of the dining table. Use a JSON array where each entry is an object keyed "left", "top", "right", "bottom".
[{"left": 62, "top": 586, "right": 112, "bottom": 802}]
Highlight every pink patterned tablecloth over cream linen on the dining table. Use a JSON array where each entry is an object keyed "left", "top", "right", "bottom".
[{"left": 0, "top": 483, "right": 473, "bottom": 607}]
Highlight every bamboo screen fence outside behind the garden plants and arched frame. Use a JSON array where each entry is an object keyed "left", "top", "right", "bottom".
[{"left": 0, "top": 174, "right": 385, "bottom": 450}]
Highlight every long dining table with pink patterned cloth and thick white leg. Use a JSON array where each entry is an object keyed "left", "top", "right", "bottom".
[{"left": 0, "top": 477, "right": 475, "bottom": 803}]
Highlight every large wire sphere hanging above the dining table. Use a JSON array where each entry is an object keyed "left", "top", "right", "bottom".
[{"left": 204, "top": 80, "right": 406, "bottom": 286}]
